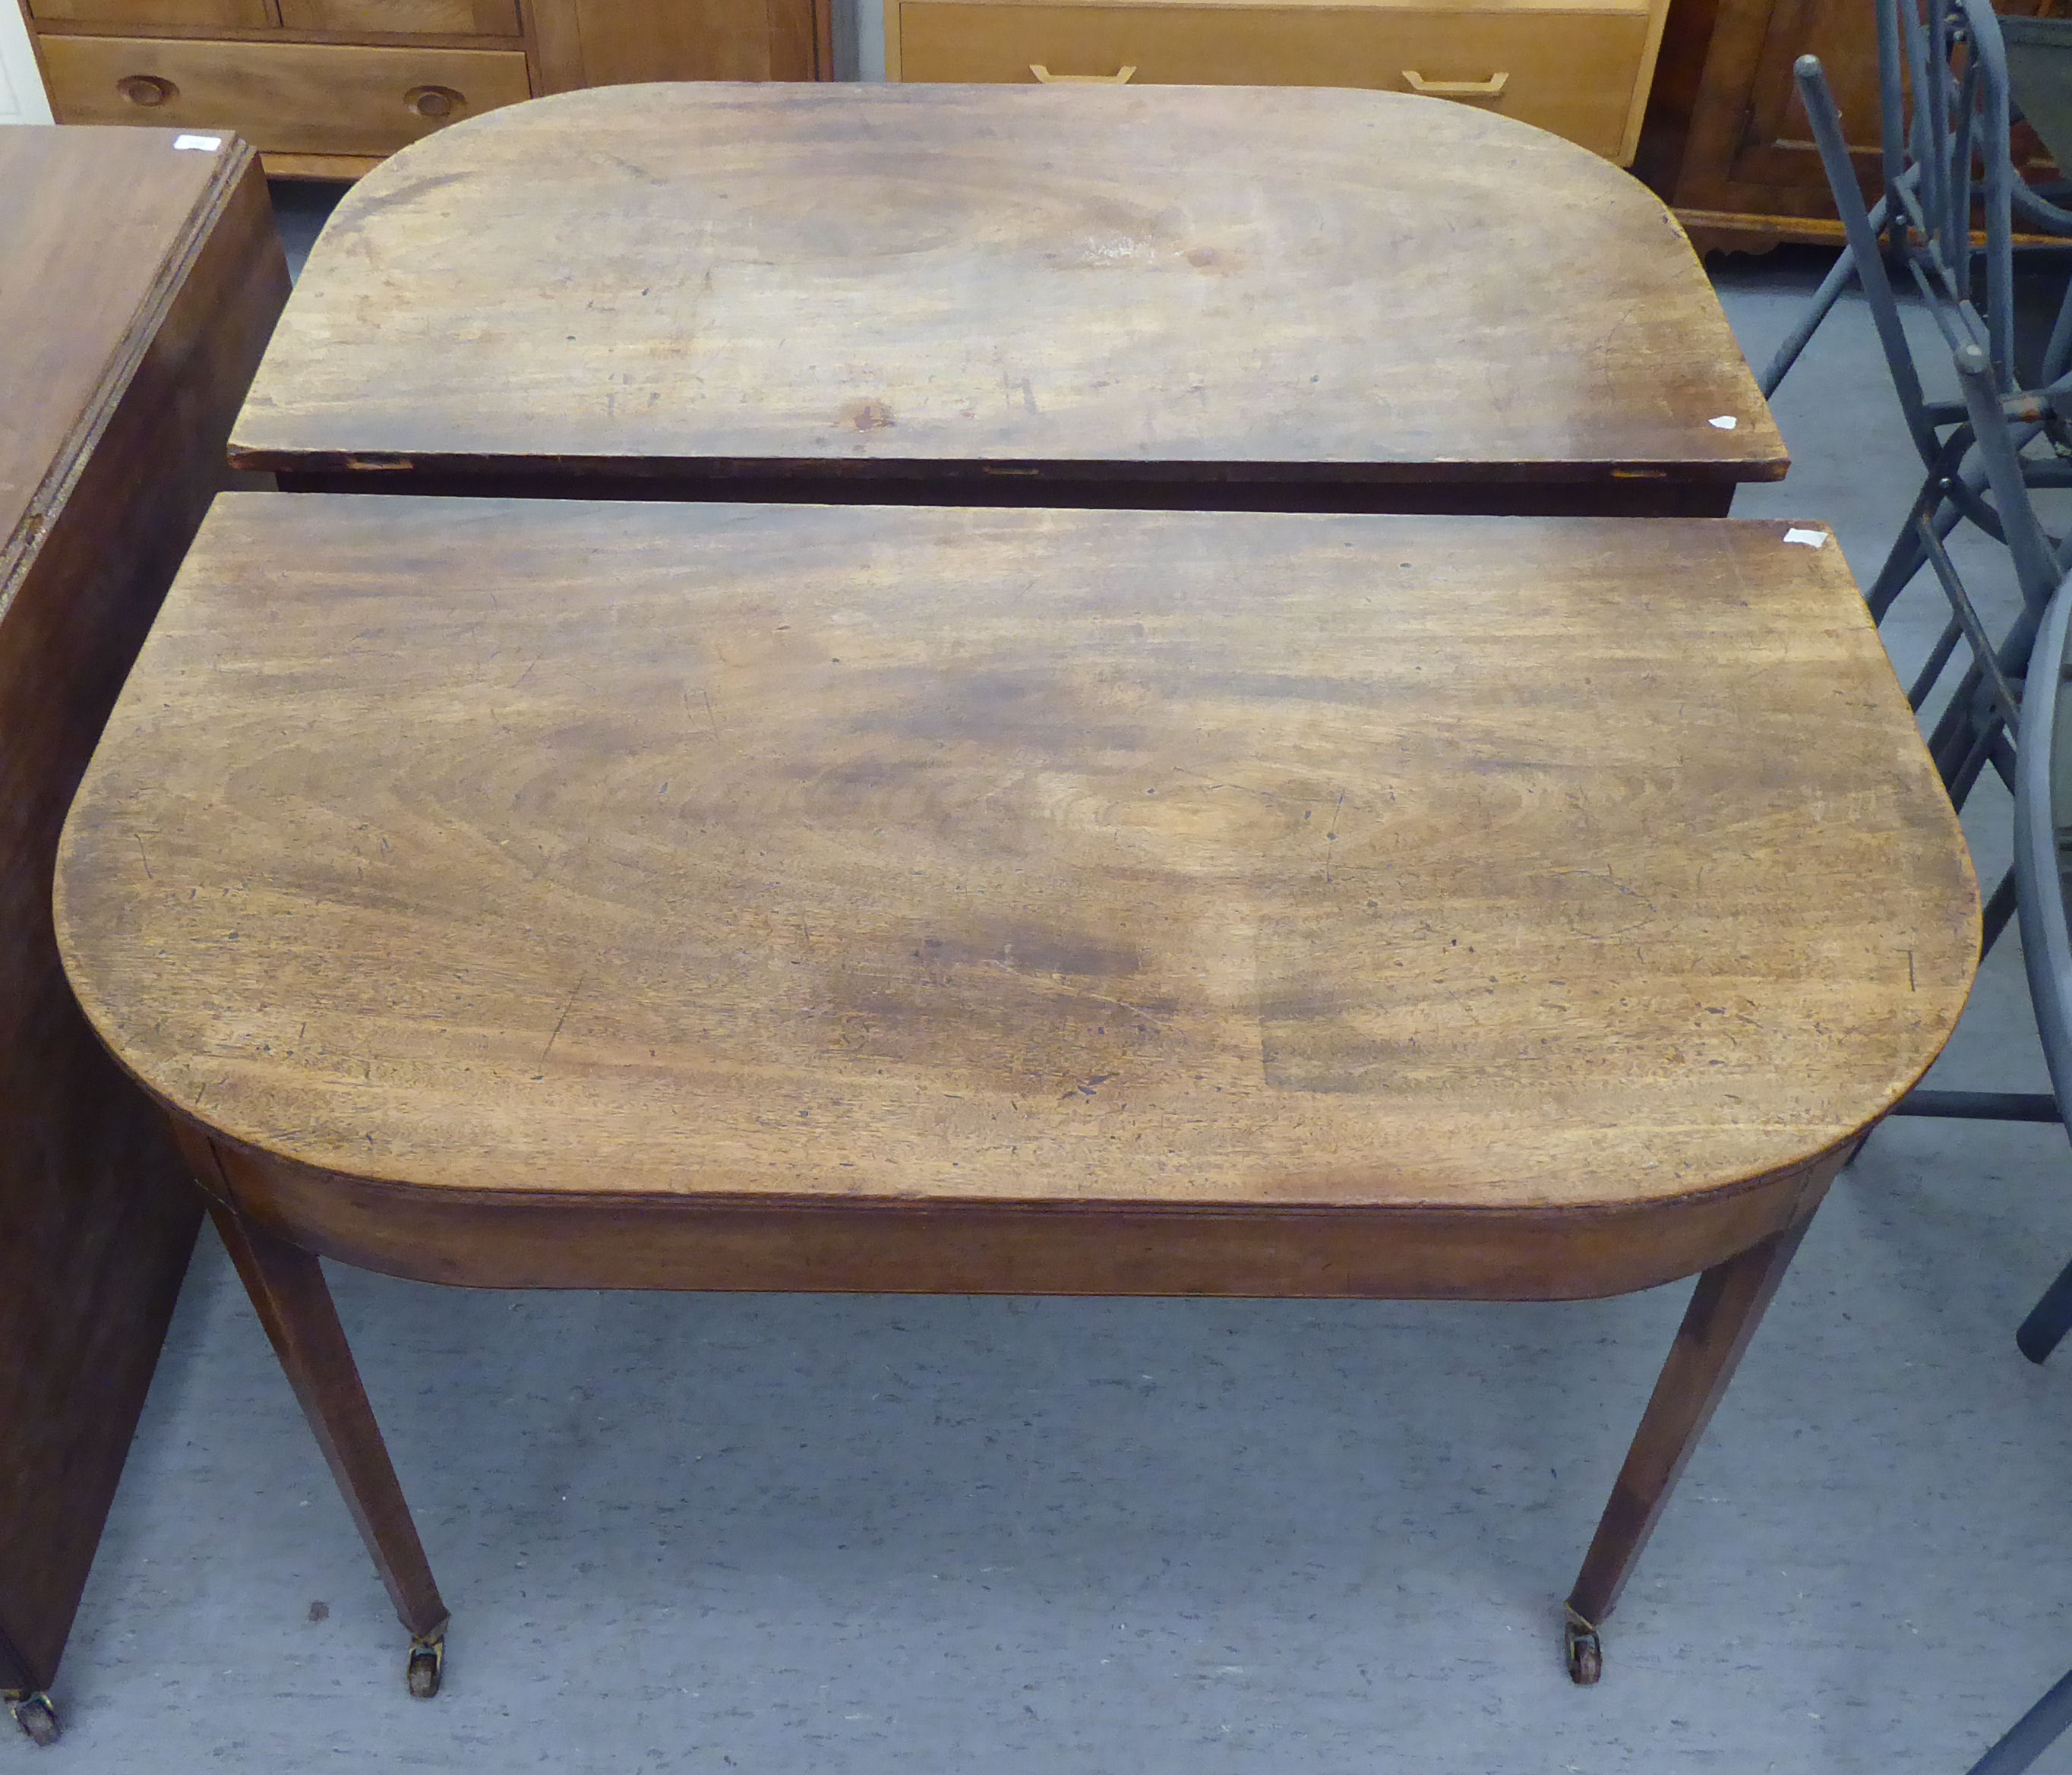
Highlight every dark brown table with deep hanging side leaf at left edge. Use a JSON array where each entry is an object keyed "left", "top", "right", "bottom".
[{"left": 0, "top": 126, "right": 288, "bottom": 1688}]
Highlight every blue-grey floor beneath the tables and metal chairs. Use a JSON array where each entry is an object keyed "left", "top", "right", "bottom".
[{"left": 12, "top": 201, "right": 2072, "bottom": 1775}]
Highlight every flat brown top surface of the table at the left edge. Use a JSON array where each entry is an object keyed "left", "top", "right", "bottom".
[{"left": 0, "top": 125, "right": 251, "bottom": 596}]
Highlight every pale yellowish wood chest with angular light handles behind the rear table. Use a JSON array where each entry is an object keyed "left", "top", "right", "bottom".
[{"left": 885, "top": 0, "right": 1668, "bottom": 166}]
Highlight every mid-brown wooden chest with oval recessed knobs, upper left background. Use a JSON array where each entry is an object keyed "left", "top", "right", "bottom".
[{"left": 18, "top": 0, "right": 833, "bottom": 178}]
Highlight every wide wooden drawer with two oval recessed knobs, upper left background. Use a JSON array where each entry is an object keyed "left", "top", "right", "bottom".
[{"left": 42, "top": 35, "right": 530, "bottom": 156}]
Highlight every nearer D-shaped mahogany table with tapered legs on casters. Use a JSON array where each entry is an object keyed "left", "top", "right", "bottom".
[{"left": 58, "top": 493, "right": 1979, "bottom": 1692}]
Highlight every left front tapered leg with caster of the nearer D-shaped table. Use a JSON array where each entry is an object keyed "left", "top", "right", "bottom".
[{"left": 182, "top": 1139, "right": 446, "bottom": 1701}]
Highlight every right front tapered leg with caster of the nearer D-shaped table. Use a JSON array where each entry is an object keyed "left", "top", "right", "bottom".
[{"left": 1566, "top": 1216, "right": 1811, "bottom": 1682}]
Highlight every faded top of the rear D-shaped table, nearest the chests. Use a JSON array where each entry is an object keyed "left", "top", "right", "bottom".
[{"left": 232, "top": 83, "right": 1786, "bottom": 491}]
